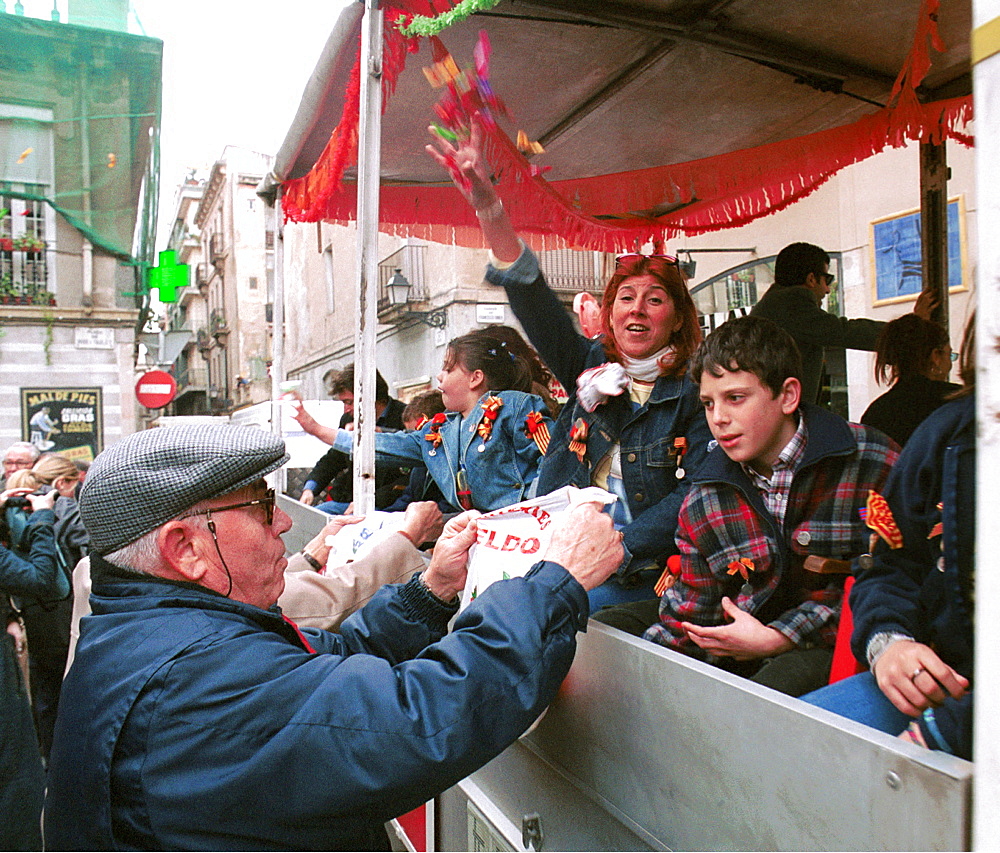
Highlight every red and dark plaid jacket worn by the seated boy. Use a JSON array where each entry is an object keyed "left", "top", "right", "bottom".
[{"left": 644, "top": 404, "right": 898, "bottom": 658}]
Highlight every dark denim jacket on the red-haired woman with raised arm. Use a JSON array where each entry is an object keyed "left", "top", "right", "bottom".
[{"left": 486, "top": 247, "right": 711, "bottom": 581}]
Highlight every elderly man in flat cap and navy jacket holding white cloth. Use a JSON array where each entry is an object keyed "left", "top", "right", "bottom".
[{"left": 45, "top": 426, "right": 622, "bottom": 850}]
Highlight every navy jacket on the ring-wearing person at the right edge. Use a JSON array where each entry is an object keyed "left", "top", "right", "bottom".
[{"left": 851, "top": 395, "right": 976, "bottom": 758}]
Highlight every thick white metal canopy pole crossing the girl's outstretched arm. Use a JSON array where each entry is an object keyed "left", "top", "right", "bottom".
[{"left": 354, "top": 0, "right": 382, "bottom": 513}]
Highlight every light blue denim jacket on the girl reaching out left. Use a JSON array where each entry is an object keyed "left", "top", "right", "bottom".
[{"left": 333, "top": 391, "right": 552, "bottom": 512}]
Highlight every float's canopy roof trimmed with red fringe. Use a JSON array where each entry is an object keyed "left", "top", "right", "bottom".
[{"left": 275, "top": 0, "right": 972, "bottom": 251}]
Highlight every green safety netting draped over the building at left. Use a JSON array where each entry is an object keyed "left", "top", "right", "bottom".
[{"left": 0, "top": 13, "right": 163, "bottom": 291}]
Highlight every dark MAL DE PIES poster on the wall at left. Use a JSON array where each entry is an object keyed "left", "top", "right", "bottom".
[{"left": 21, "top": 388, "right": 104, "bottom": 462}]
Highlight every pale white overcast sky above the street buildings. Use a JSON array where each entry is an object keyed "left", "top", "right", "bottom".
[{"left": 15, "top": 0, "right": 351, "bottom": 249}]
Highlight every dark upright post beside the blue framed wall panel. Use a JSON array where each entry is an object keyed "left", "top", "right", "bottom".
[{"left": 920, "top": 142, "right": 950, "bottom": 330}]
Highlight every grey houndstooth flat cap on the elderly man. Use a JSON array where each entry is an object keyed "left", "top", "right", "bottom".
[{"left": 80, "top": 424, "right": 289, "bottom": 554}]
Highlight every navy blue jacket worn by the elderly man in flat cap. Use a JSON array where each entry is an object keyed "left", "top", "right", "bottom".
[{"left": 45, "top": 561, "right": 588, "bottom": 850}]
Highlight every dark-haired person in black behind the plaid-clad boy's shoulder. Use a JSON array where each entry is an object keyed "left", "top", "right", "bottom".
[{"left": 861, "top": 314, "right": 961, "bottom": 447}]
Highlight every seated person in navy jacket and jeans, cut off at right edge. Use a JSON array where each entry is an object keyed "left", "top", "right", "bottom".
[{"left": 802, "top": 316, "right": 976, "bottom": 760}]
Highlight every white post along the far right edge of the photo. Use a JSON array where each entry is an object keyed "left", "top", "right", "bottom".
[{"left": 972, "top": 0, "right": 1000, "bottom": 850}]
